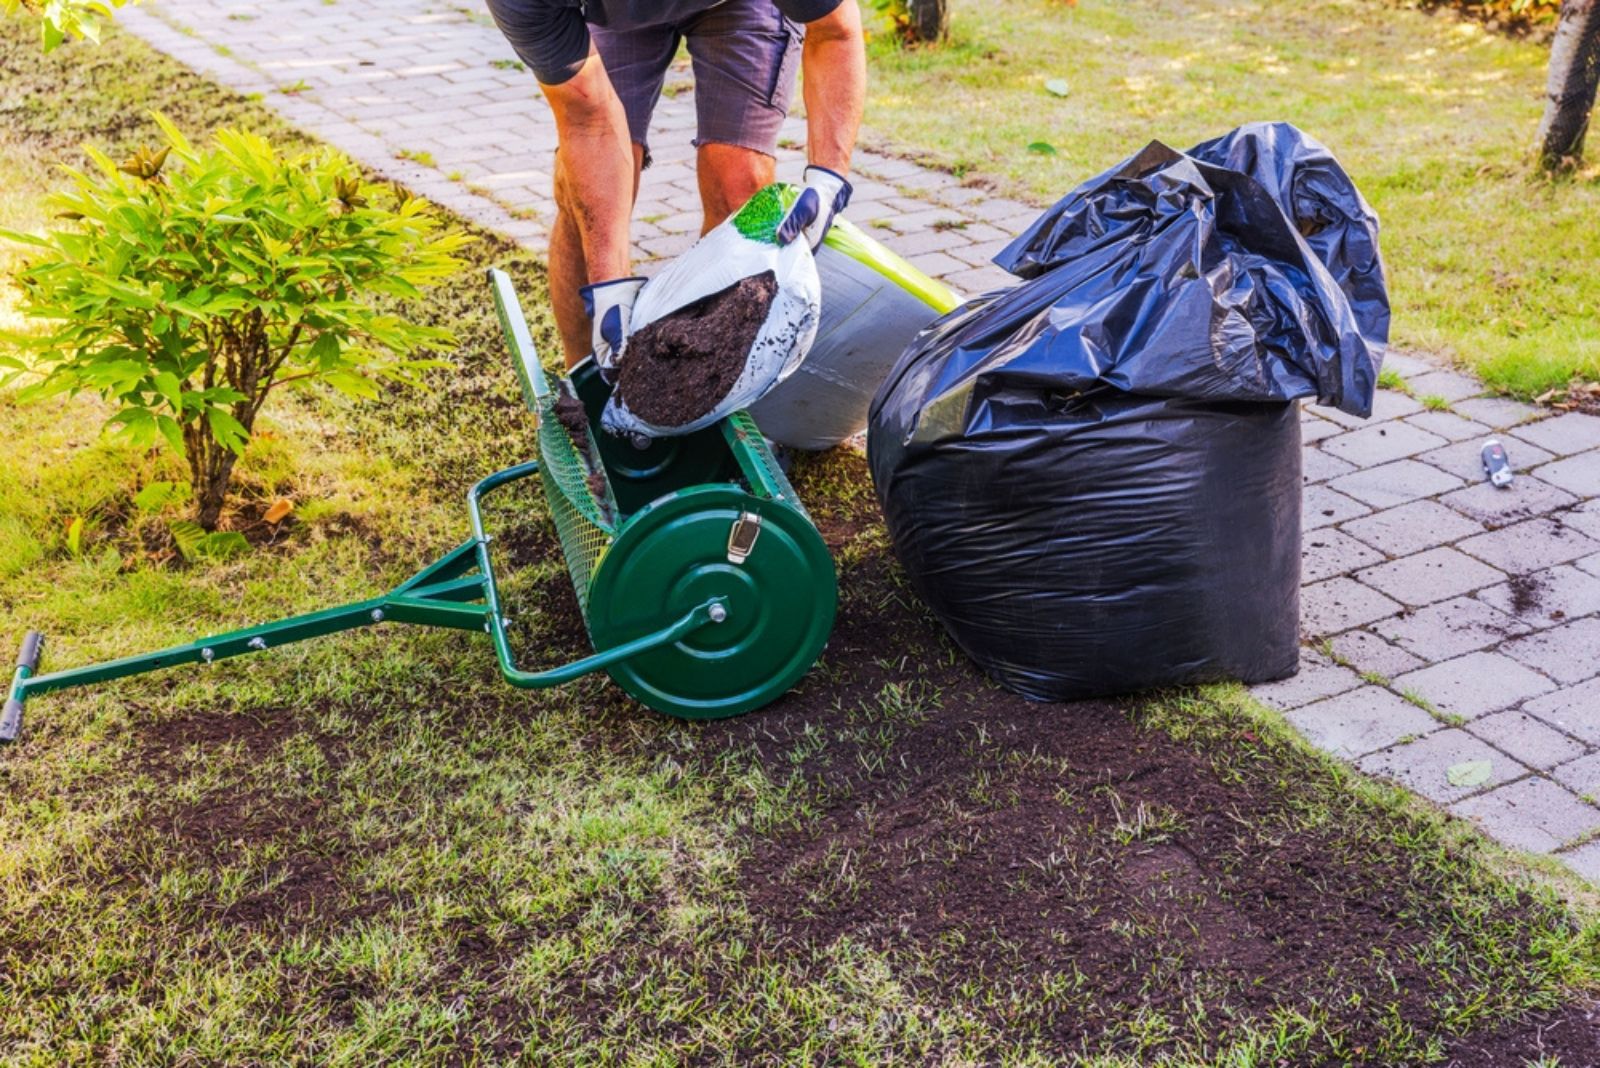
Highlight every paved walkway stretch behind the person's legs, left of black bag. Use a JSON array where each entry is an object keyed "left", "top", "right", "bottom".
[{"left": 122, "top": 0, "right": 1011, "bottom": 291}]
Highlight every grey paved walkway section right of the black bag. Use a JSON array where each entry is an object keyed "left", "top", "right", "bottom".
[{"left": 1256, "top": 375, "right": 1600, "bottom": 879}]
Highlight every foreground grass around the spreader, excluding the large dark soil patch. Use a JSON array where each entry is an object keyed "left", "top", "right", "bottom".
[{"left": 9, "top": 12, "right": 1592, "bottom": 1068}]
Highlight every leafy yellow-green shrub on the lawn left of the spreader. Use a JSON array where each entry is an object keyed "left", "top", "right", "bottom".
[{"left": 0, "top": 115, "right": 469, "bottom": 531}]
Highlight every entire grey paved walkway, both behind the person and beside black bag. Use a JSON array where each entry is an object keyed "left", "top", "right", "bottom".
[{"left": 120, "top": 0, "right": 1600, "bottom": 879}]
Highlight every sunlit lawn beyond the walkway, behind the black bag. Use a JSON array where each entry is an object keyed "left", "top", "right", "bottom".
[{"left": 867, "top": 0, "right": 1600, "bottom": 397}]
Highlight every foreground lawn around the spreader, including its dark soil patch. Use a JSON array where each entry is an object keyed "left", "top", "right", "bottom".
[{"left": 0, "top": 10, "right": 1600, "bottom": 1068}]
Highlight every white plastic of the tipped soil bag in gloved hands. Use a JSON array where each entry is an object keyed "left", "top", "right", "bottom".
[{"left": 600, "top": 182, "right": 822, "bottom": 438}]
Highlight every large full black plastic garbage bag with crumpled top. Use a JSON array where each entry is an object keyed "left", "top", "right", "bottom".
[{"left": 867, "top": 125, "right": 1389, "bottom": 700}]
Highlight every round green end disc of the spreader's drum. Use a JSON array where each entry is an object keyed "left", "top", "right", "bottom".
[{"left": 589, "top": 484, "right": 838, "bottom": 719}]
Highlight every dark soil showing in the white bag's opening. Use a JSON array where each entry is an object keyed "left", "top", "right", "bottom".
[{"left": 618, "top": 270, "right": 778, "bottom": 427}]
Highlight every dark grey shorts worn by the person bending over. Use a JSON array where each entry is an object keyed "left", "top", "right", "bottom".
[{"left": 589, "top": 0, "right": 805, "bottom": 166}]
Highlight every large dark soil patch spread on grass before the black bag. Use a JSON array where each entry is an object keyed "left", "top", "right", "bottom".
[{"left": 725, "top": 447, "right": 1587, "bottom": 1063}]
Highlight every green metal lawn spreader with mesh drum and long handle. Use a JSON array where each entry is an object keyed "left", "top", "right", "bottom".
[{"left": 0, "top": 270, "right": 837, "bottom": 742}]
